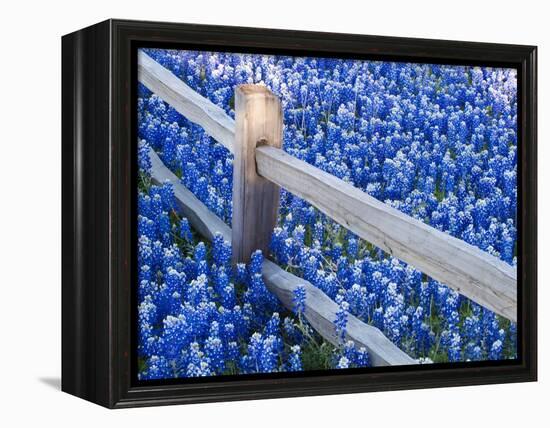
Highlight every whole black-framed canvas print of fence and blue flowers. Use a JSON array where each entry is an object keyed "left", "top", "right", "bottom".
[{"left": 62, "top": 20, "right": 537, "bottom": 408}]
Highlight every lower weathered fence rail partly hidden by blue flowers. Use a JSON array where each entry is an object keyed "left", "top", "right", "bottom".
[{"left": 149, "top": 150, "right": 416, "bottom": 366}]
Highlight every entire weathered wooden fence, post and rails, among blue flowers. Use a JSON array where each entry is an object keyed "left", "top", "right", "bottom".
[{"left": 138, "top": 51, "right": 517, "bottom": 365}]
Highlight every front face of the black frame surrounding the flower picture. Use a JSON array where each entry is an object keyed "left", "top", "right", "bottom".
[{"left": 84, "top": 20, "right": 536, "bottom": 408}]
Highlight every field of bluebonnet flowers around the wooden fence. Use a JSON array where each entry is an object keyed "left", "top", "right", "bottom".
[{"left": 137, "top": 49, "right": 517, "bottom": 380}]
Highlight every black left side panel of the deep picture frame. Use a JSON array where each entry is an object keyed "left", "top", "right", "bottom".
[{"left": 62, "top": 22, "right": 113, "bottom": 407}]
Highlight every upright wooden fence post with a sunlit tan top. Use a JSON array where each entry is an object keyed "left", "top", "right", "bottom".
[{"left": 231, "top": 85, "right": 283, "bottom": 263}]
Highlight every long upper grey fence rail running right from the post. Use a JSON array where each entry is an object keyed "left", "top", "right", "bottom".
[{"left": 256, "top": 146, "right": 517, "bottom": 321}]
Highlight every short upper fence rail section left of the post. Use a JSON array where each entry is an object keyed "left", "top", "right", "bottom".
[{"left": 138, "top": 50, "right": 235, "bottom": 152}]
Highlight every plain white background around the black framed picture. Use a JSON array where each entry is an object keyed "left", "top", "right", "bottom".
[{"left": 0, "top": 0, "right": 550, "bottom": 428}]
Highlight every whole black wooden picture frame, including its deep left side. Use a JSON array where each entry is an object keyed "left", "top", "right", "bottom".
[{"left": 62, "top": 19, "right": 537, "bottom": 408}]
